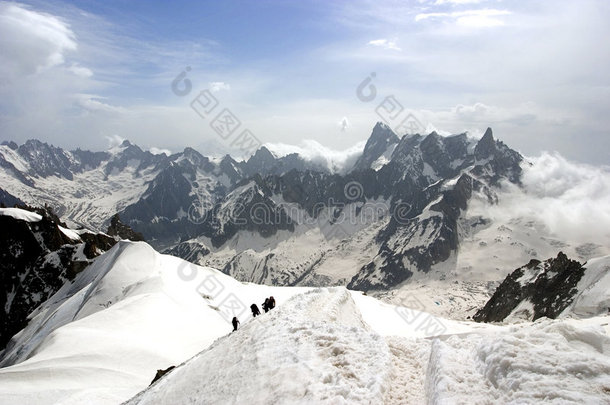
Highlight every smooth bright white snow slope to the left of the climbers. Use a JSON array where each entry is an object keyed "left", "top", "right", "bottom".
[{"left": 0, "top": 241, "right": 303, "bottom": 404}]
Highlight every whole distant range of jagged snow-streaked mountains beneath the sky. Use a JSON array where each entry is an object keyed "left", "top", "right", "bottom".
[{"left": 0, "top": 123, "right": 610, "bottom": 296}]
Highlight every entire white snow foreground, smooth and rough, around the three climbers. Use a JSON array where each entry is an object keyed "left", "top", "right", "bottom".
[{"left": 0, "top": 241, "right": 610, "bottom": 405}]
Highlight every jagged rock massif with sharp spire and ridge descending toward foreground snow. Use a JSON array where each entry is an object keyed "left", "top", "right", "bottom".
[{"left": 348, "top": 124, "right": 523, "bottom": 290}]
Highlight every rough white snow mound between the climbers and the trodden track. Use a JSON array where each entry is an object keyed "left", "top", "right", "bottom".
[{"left": 128, "top": 289, "right": 391, "bottom": 404}]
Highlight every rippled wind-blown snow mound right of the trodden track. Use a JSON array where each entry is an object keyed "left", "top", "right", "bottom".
[{"left": 426, "top": 320, "right": 610, "bottom": 404}]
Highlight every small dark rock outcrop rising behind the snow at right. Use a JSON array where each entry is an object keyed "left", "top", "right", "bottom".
[{"left": 473, "top": 252, "right": 586, "bottom": 322}]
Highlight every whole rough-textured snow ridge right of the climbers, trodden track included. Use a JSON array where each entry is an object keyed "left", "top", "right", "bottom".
[{"left": 127, "top": 288, "right": 610, "bottom": 405}]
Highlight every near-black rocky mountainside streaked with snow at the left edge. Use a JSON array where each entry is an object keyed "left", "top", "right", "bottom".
[{"left": 0, "top": 208, "right": 116, "bottom": 349}]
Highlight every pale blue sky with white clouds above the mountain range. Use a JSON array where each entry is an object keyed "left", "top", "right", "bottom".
[{"left": 0, "top": 0, "right": 610, "bottom": 165}]
